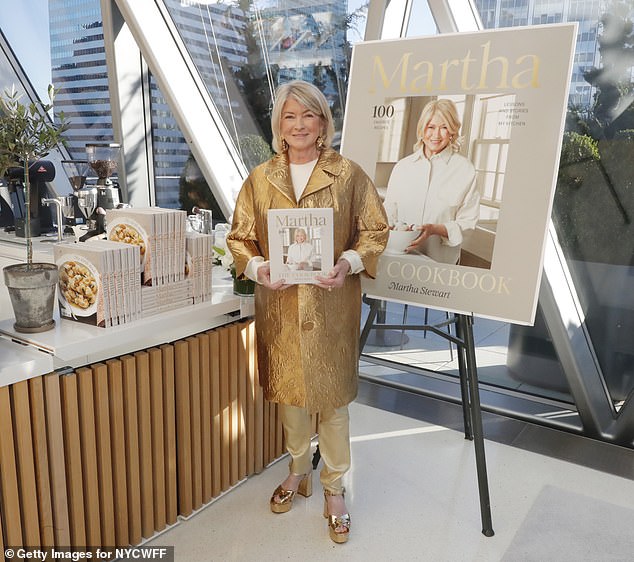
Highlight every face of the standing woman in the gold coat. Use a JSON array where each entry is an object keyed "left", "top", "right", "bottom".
[{"left": 280, "top": 97, "right": 322, "bottom": 159}]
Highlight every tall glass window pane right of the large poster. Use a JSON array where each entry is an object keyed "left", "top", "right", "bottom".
[{"left": 476, "top": 0, "right": 634, "bottom": 403}]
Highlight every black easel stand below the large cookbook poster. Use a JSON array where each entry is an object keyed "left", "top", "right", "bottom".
[{"left": 359, "top": 298, "right": 494, "bottom": 537}]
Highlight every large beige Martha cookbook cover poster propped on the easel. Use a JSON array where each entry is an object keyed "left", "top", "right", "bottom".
[{"left": 341, "top": 24, "right": 576, "bottom": 324}]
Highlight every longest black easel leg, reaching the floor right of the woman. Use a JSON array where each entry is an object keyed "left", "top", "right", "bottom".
[{"left": 458, "top": 314, "right": 494, "bottom": 537}]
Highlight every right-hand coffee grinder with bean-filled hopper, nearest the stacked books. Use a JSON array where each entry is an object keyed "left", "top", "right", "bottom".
[{"left": 86, "top": 143, "right": 121, "bottom": 233}]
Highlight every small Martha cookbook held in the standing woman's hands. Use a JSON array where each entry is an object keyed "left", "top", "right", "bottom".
[{"left": 268, "top": 209, "right": 334, "bottom": 285}]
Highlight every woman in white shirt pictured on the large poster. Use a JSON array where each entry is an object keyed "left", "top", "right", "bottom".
[{"left": 385, "top": 99, "right": 480, "bottom": 264}]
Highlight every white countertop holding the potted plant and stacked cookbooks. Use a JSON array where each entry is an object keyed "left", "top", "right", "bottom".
[{"left": 0, "top": 235, "right": 253, "bottom": 386}]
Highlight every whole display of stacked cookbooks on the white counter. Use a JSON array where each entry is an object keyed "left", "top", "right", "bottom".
[{"left": 54, "top": 207, "right": 218, "bottom": 328}]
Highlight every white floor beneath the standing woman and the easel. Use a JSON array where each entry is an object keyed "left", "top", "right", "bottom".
[{"left": 142, "top": 385, "right": 634, "bottom": 562}]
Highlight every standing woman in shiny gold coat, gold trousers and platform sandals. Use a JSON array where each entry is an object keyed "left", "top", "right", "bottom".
[{"left": 227, "top": 81, "right": 388, "bottom": 543}]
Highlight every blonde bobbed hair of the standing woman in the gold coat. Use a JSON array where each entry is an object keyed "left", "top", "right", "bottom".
[{"left": 271, "top": 80, "right": 335, "bottom": 154}]
